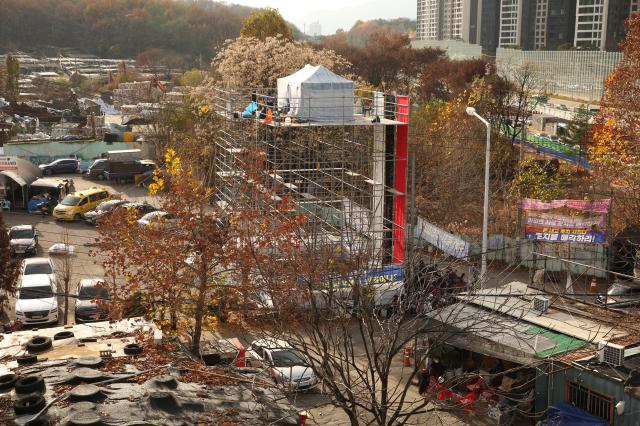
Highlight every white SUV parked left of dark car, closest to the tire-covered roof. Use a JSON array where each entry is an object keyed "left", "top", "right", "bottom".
[{"left": 16, "top": 274, "right": 58, "bottom": 325}]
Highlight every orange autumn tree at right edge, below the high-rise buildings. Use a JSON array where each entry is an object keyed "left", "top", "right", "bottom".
[{"left": 589, "top": 15, "right": 640, "bottom": 223}]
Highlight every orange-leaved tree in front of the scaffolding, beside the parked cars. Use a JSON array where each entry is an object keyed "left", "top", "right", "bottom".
[{"left": 96, "top": 150, "right": 298, "bottom": 354}]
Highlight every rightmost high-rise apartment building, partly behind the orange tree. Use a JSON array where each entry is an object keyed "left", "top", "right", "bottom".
[{"left": 574, "top": 0, "right": 637, "bottom": 51}]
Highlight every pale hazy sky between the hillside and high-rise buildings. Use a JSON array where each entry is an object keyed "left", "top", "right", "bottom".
[{"left": 226, "top": 0, "right": 416, "bottom": 35}]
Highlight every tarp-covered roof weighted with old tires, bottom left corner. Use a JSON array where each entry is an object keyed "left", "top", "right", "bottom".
[{"left": 0, "top": 318, "right": 296, "bottom": 425}]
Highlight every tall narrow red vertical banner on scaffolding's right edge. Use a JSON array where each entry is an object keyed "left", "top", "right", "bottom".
[{"left": 393, "top": 96, "right": 409, "bottom": 263}]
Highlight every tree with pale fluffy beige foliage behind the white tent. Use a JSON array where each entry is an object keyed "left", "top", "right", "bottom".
[{"left": 212, "top": 36, "right": 351, "bottom": 87}]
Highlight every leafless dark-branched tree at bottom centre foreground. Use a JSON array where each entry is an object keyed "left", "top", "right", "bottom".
[{"left": 238, "top": 211, "right": 532, "bottom": 425}]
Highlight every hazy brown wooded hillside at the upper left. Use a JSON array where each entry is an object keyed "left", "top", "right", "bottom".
[{"left": 0, "top": 0, "right": 254, "bottom": 64}]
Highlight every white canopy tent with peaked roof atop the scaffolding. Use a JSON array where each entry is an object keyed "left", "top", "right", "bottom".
[{"left": 278, "top": 64, "right": 355, "bottom": 122}]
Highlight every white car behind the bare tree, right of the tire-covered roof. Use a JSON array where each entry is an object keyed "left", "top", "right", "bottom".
[{"left": 247, "top": 339, "right": 318, "bottom": 390}]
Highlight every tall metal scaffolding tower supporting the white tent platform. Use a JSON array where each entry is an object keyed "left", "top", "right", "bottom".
[{"left": 213, "top": 84, "right": 409, "bottom": 266}]
